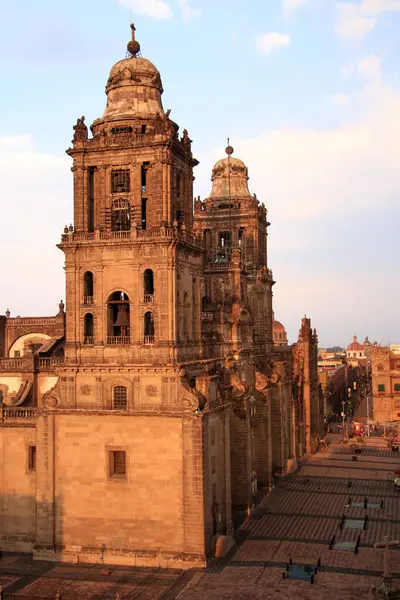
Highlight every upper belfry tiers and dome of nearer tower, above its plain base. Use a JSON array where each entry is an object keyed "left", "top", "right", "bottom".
[{"left": 60, "top": 25, "right": 201, "bottom": 363}]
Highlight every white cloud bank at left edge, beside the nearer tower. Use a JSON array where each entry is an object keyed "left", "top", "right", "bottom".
[{"left": 0, "top": 134, "right": 73, "bottom": 316}]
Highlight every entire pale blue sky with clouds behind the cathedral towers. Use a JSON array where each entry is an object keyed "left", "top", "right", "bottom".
[{"left": 0, "top": 0, "right": 400, "bottom": 345}]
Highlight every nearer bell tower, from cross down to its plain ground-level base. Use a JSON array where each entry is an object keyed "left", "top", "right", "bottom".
[{"left": 35, "top": 25, "right": 212, "bottom": 568}]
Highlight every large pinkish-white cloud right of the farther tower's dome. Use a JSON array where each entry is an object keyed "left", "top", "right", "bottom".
[{"left": 196, "top": 84, "right": 400, "bottom": 223}]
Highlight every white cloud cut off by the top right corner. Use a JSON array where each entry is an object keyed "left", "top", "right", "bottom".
[{"left": 335, "top": 0, "right": 400, "bottom": 38}]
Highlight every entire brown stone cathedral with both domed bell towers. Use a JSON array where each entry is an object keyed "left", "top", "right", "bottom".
[{"left": 0, "top": 25, "right": 323, "bottom": 568}]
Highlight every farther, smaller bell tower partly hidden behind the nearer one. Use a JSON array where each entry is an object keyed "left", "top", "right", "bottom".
[{"left": 194, "top": 144, "right": 274, "bottom": 356}]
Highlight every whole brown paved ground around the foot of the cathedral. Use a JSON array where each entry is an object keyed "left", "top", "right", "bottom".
[{"left": 0, "top": 436, "right": 400, "bottom": 600}]
